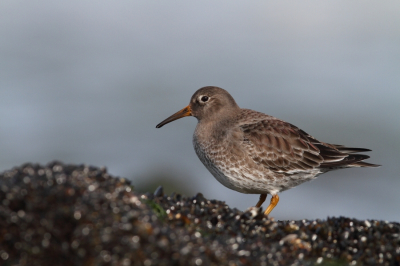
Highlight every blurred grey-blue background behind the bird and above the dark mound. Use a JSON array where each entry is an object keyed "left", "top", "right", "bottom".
[{"left": 0, "top": 0, "right": 400, "bottom": 221}]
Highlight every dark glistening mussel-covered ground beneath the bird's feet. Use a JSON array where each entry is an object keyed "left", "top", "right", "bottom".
[{"left": 0, "top": 162, "right": 400, "bottom": 266}]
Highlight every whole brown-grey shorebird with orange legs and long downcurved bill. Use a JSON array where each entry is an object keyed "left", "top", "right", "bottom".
[{"left": 157, "top": 87, "right": 378, "bottom": 214}]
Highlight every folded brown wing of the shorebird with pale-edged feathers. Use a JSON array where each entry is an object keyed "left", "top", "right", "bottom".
[{"left": 240, "top": 116, "right": 369, "bottom": 173}]
